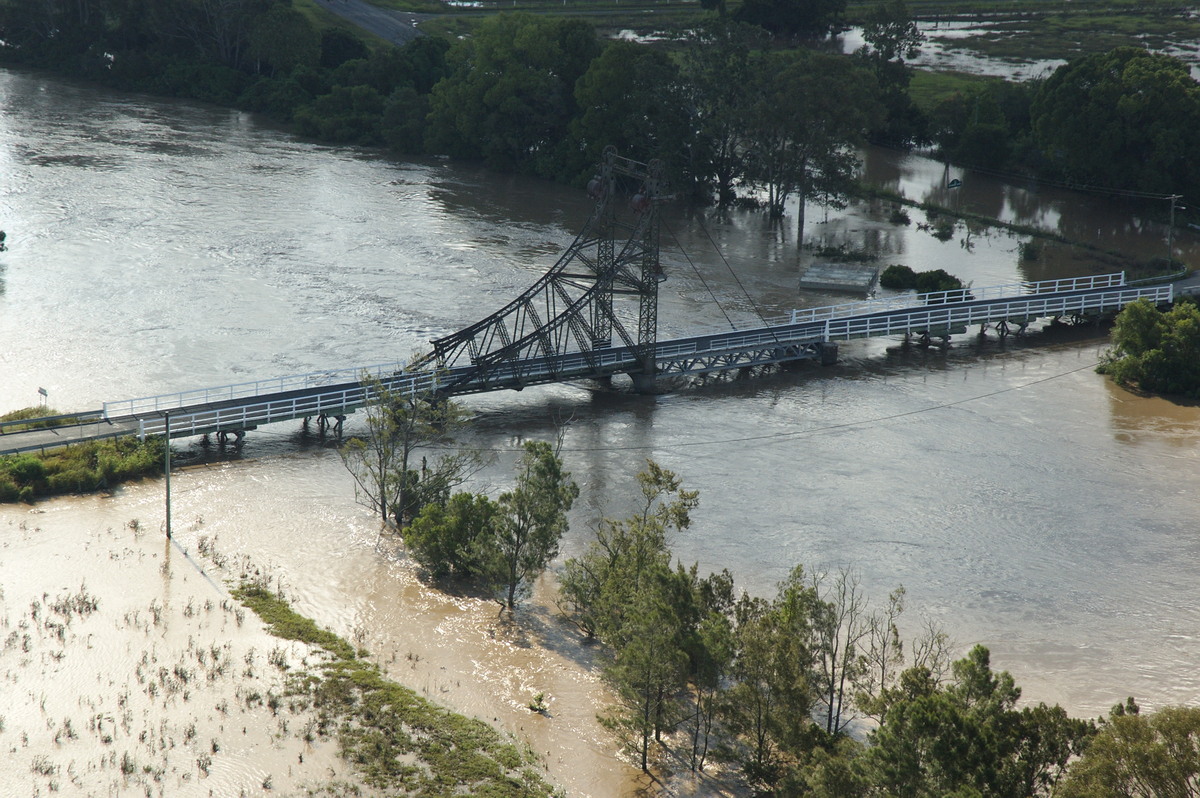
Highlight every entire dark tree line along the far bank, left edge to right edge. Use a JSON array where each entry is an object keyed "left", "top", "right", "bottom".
[{"left": 7, "top": 0, "right": 1200, "bottom": 216}]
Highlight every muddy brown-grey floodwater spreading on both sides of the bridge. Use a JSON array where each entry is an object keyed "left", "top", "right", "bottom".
[{"left": 0, "top": 71, "right": 1200, "bottom": 796}]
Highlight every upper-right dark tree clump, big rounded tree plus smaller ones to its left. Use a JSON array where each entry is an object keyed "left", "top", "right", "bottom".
[{"left": 930, "top": 47, "right": 1200, "bottom": 202}]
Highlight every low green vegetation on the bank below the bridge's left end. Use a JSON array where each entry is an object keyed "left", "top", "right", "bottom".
[{"left": 0, "top": 436, "right": 166, "bottom": 502}]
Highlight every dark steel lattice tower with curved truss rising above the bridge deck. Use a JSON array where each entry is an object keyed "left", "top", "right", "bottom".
[{"left": 409, "top": 146, "right": 665, "bottom": 394}]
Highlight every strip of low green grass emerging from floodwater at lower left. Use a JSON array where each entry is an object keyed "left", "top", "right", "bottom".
[{"left": 234, "top": 584, "right": 554, "bottom": 798}]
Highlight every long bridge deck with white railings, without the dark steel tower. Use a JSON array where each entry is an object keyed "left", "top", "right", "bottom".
[{"left": 0, "top": 274, "right": 1174, "bottom": 455}]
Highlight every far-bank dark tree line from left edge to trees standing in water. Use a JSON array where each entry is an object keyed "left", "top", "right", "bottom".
[{"left": 0, "top": 0, "right": 902, "bottom": 236}]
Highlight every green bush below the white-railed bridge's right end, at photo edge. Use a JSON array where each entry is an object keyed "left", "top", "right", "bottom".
[{"left": 1099, "top": 299, "right": 1200, "bottom": 398}]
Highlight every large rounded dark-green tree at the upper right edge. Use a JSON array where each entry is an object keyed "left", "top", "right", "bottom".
[{"left": 1031, "top": 47, "right": 1200, "bottom": 193}]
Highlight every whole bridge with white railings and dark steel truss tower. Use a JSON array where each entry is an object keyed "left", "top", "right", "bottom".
[{"left": 0, "top": 148, "right": 1175, "bottom": 455}]
